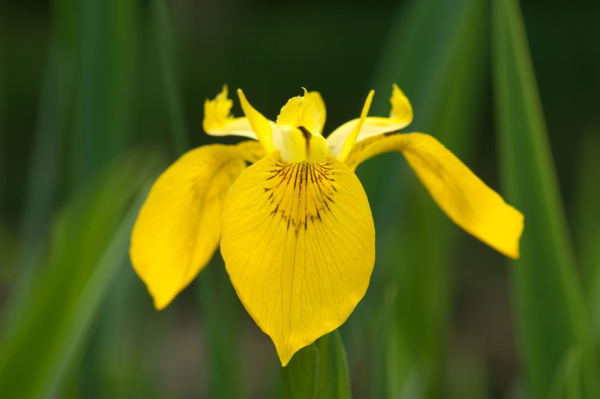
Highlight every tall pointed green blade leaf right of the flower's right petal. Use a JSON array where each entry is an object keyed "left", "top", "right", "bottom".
[{"left": 493, "top": 0, "right": 600, "bottom": 399}]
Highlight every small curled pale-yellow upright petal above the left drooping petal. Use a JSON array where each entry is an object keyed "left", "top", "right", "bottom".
[{"left": 202, "top": 85, "right": 258, "bottom": 140}]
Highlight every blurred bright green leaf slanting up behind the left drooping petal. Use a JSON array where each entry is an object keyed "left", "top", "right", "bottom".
[{"left": 0, "top": 151, "right": 160, "bottom": 398}]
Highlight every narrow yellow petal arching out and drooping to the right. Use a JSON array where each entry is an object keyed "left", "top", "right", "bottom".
[{"left": 346, "top": 133, "right": 523, "bottom": 259}]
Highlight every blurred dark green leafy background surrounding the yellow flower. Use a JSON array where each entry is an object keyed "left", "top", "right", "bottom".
[{"left": 0, "top": 0, "right": 600, "bottom": 399}]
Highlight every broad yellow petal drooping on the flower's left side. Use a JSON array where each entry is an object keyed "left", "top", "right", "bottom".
[{"left": 130, "top": 142, "right": 265, "bottom": 310}]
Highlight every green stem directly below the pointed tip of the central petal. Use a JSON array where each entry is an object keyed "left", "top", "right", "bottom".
[{"left": 281, "top": 330, "right": 352, "bottom": 399}]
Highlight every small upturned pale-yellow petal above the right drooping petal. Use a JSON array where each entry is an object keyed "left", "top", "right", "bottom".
[{"left": 327, "top": 84, "right": 413, "bottom": 157}]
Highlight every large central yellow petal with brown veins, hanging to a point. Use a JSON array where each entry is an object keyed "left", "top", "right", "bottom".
[{"left": 221, "top": 152, "right": 375, "bottom": 366}]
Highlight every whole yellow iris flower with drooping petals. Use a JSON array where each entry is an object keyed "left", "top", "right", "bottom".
[{"left": 130, "top": 85, "right": 523, "bottom": 366}]
